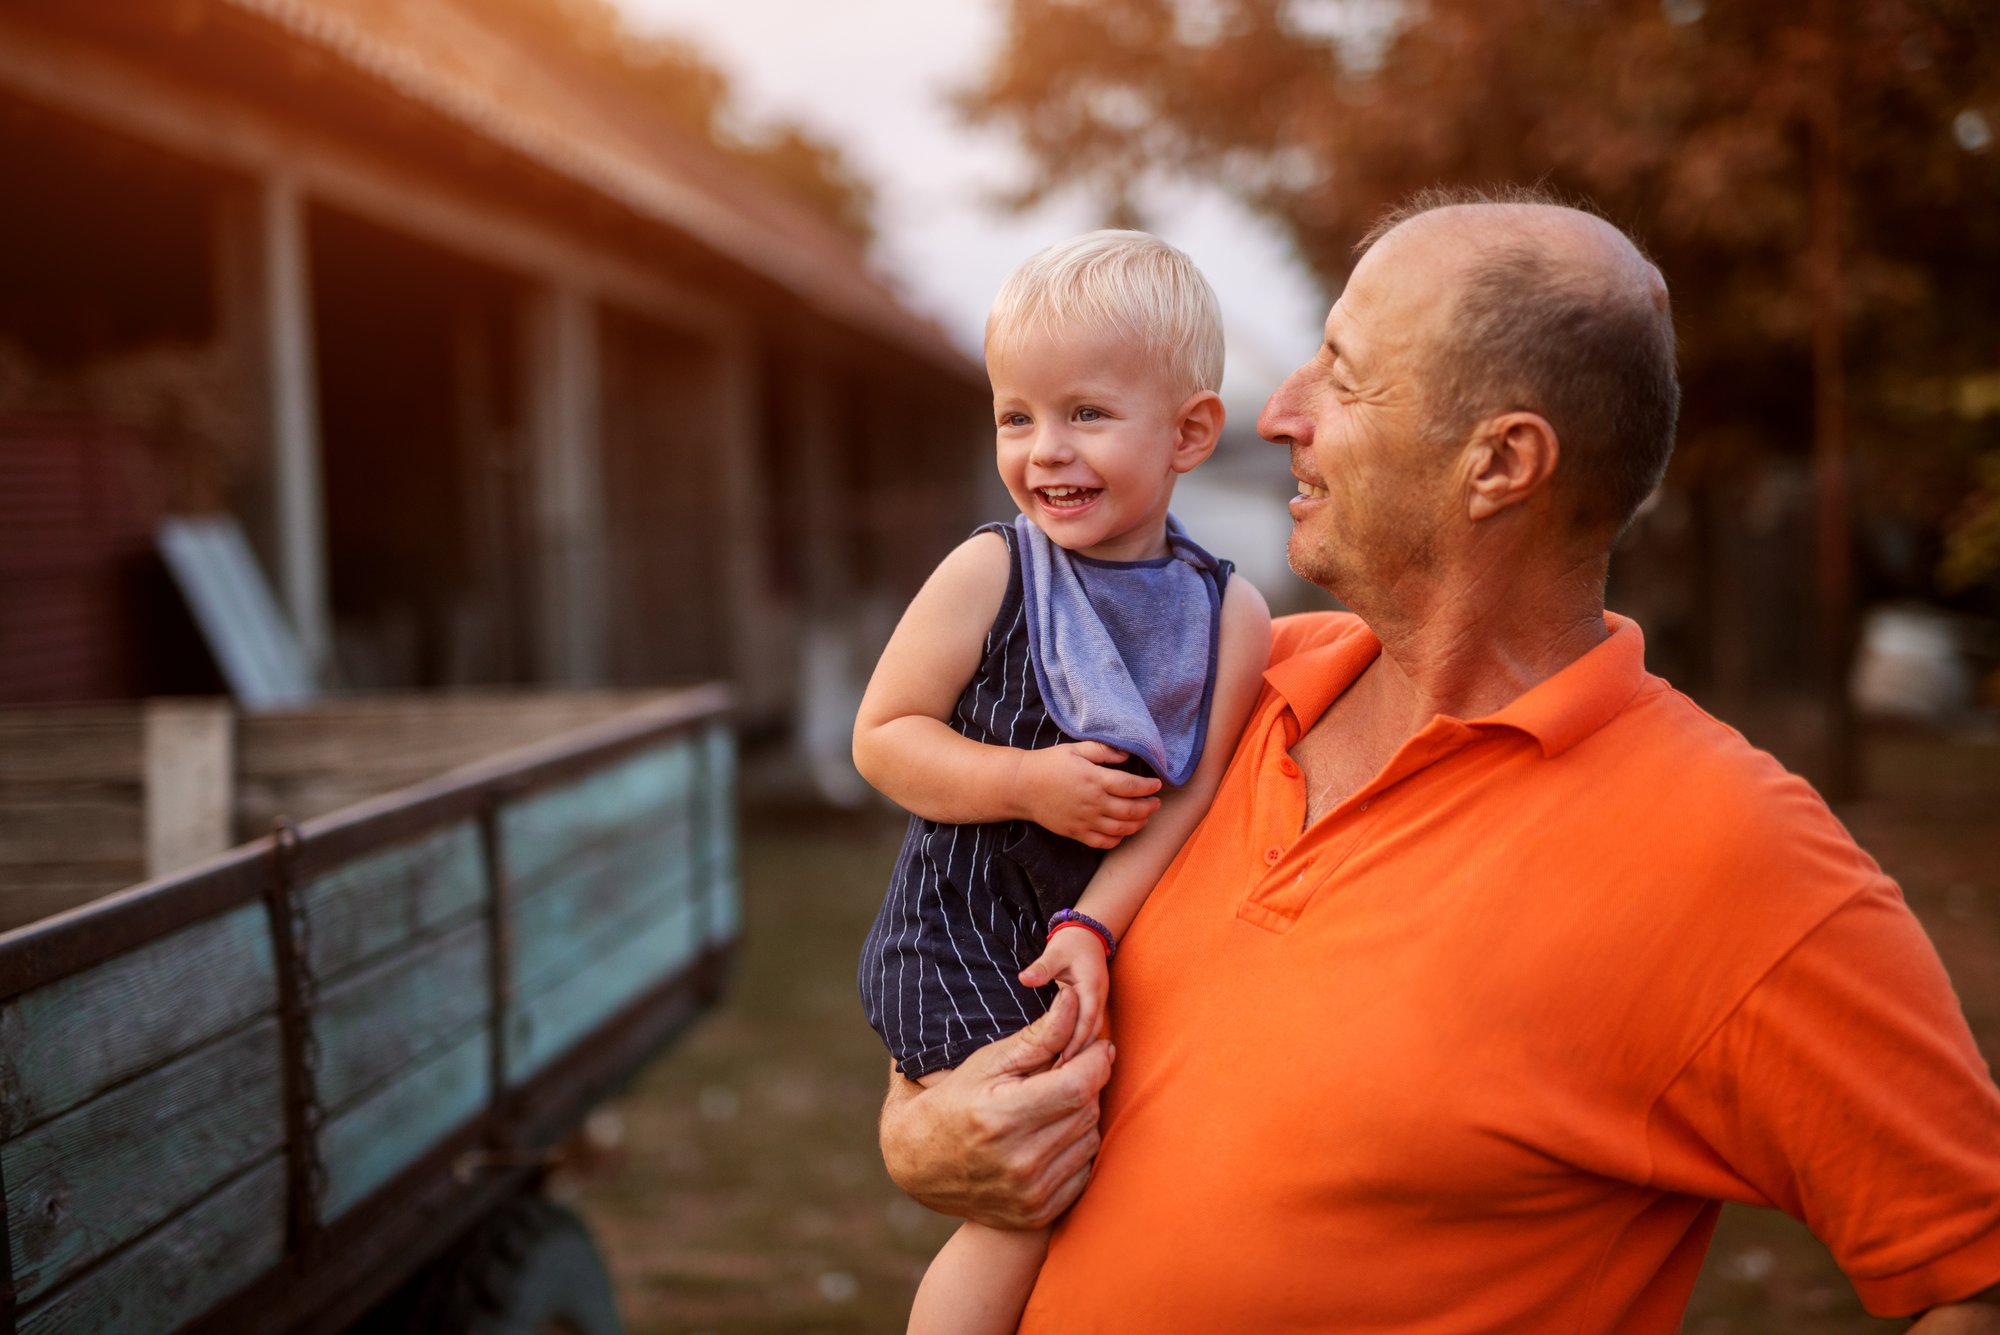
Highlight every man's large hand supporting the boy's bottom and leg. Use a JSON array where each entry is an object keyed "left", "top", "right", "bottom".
[{"left": 882, "top": 989, "right": 1112, "bottom": 1229}]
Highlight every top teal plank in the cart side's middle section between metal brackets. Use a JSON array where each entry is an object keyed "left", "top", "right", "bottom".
[{"left": 302, "top": 821, "right": 486, "bottom": 983}]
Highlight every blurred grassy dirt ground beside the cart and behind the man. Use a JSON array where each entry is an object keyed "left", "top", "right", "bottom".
[{"left": 578, "top": 733, "right": 2000, "bottom": 1335}]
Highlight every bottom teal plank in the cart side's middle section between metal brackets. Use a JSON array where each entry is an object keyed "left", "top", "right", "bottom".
[{"left": 320, "top": 1029, "right": 492, "bottom": 1221}]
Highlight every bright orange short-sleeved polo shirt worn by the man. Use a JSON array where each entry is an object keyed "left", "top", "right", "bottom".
[{"left": 1022, "top": 614, "right": 2000, "bottom": 1335}]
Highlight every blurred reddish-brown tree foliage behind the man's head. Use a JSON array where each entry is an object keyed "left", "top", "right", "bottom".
[{"left": 964, "top": 0, "right": 2000, "bottom": 599}]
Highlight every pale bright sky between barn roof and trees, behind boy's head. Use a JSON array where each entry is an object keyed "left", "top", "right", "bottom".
[{"left": 618, "top": 0, "right": 1326, "bottom": 422}]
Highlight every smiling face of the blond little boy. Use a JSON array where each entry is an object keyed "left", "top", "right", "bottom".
[{"left": 986, "top": 328, "right": 1220, "bottom": 562}]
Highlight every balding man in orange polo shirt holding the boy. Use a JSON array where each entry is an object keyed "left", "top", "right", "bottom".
[{"left": 882, "top": 189, "right": 2000, "bottom": 1335}]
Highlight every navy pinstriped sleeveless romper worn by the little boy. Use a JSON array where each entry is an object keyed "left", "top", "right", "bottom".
[{"left": 858, "top": 524, "right": 1230, "bottom": 1079}]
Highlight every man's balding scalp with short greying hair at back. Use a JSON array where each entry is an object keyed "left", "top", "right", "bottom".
[{"left": 1360, "top": 190, "right": 1680, "bottom": 534}]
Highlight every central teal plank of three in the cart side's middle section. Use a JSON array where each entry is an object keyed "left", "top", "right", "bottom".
[{"left": 312, "top": 917, "right": 492, "bottom": 1111}]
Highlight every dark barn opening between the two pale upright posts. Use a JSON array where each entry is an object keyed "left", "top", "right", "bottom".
[{"left": 308, "top": 208, "right": 528, "bottom": 687}]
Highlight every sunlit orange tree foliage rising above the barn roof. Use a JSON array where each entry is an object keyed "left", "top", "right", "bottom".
[{"left": 484, "top": 0, "right": 874, "bottom": 246}]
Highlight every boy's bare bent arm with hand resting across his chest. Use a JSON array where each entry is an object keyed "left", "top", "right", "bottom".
[{"left": 854, "top": 534, "right": 1160, "bottom": 847}]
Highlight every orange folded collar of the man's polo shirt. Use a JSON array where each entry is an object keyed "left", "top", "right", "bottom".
[{"left": 1264, "top": 612, "right": 1646, "bottom": 757}]
